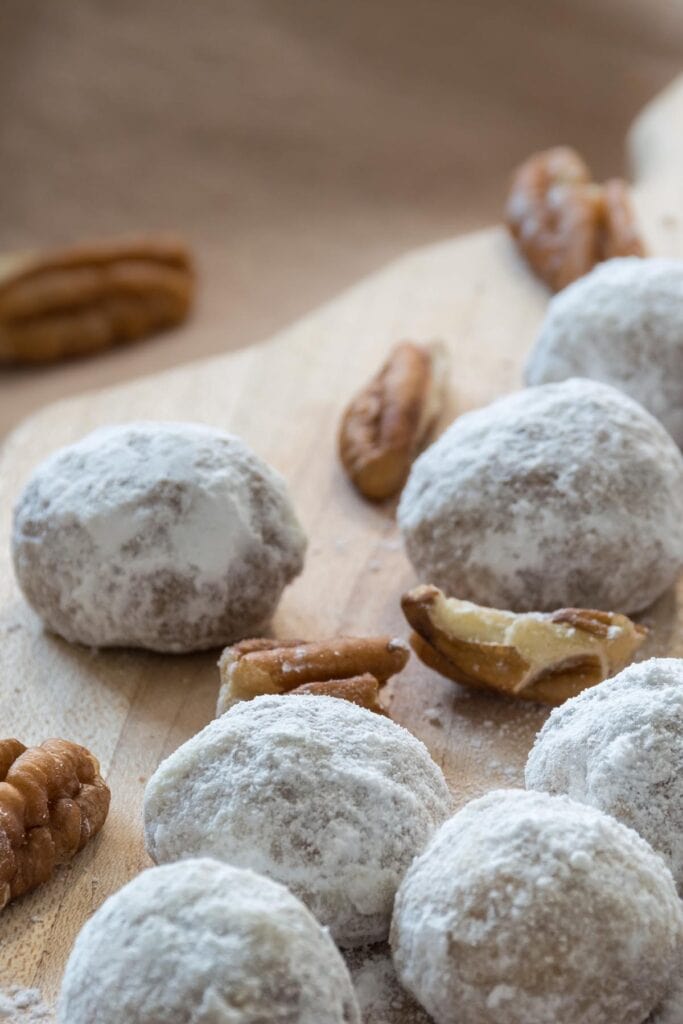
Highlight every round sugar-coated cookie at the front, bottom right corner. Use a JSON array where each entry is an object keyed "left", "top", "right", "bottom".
[{"left": 391, "top": 790, "right": 683, "bottom": 1024}]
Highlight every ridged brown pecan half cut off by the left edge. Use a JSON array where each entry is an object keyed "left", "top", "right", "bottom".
[{"left": 0, "top": 739, "right": 110, "bottom": 908}]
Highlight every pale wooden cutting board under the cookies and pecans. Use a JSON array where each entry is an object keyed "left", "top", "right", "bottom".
[{"left": 0, "top": 79, "right": 683, "bottom": 1015}]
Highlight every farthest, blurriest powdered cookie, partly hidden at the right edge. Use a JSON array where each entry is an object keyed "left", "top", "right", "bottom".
[{"left": 524, "top": 257, "right": 683, "bottom": 445}]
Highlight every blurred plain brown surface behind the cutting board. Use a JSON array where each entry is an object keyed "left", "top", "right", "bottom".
[{"left": 0, "top": 0, "right": 683, "bottom": 434}]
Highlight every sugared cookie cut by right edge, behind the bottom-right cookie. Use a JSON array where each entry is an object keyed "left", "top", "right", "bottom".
[{"left": 525, "top": 657, "right": 683, "bottom": 892}]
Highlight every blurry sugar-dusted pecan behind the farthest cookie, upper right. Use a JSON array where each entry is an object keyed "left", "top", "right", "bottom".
[{"left": 506, "top": 146, "right": 644, "bottom": 291}]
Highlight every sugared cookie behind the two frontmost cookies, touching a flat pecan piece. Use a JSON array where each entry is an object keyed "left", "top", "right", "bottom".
[{"left": 144, "top": 696, "right": 451, "bottom": 946}]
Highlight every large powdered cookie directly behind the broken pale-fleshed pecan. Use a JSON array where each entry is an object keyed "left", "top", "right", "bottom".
[{"left": 398, "top": 380, "right": 683, "bottom": 613}]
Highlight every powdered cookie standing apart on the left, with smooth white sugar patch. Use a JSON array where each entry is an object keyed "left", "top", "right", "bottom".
[{"left": 12, "top": 423, "right": 305, "bottom": 652}]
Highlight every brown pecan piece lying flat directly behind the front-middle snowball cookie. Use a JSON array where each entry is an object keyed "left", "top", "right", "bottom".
[{"left": 216, "top": 636, "right": 410, "bottom": 716}]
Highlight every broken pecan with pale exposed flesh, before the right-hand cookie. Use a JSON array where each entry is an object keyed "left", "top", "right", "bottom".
[{"left": 401, "top": 586, "right": 647, "bottom": 705}]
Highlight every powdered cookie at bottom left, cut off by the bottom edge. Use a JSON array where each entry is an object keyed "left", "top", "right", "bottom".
[{"left": 58, "top": 858, "right": 360, "bottom": 1024}]
